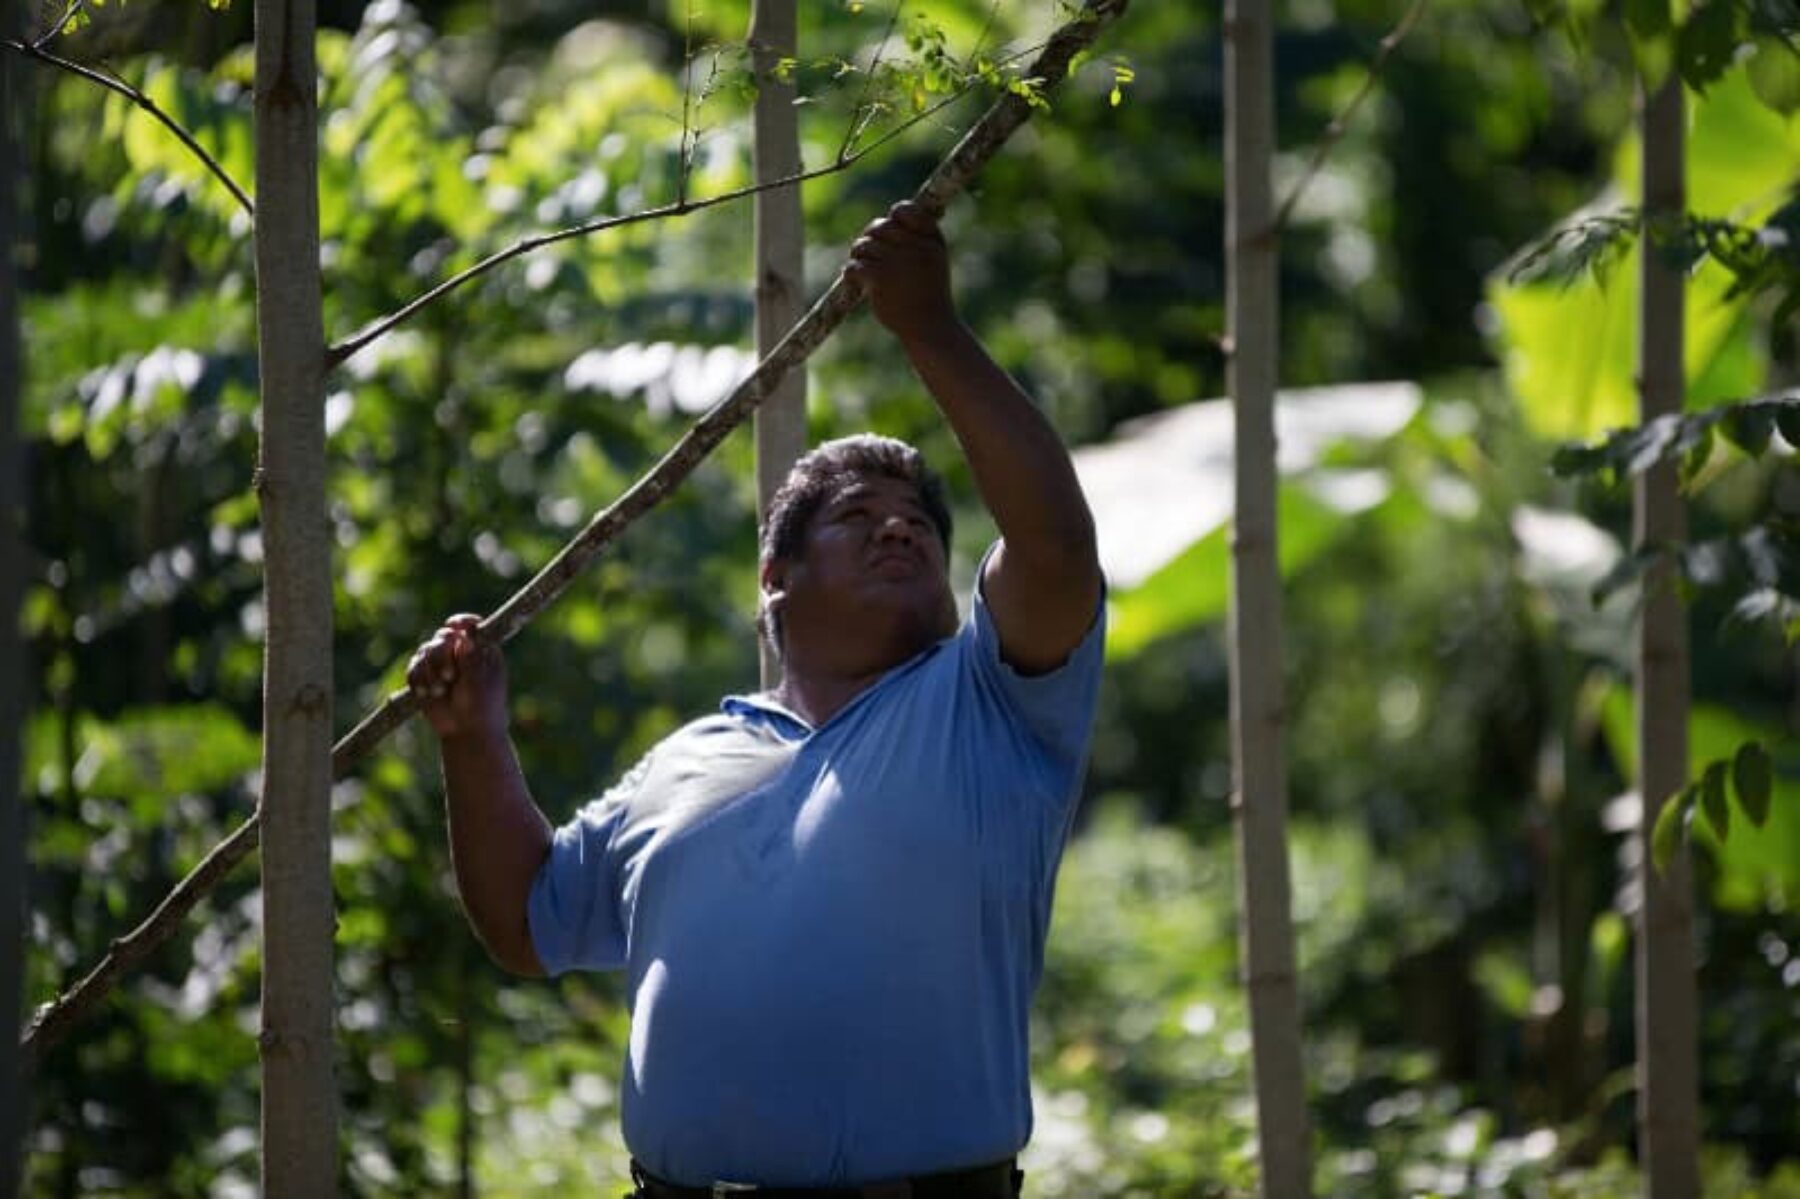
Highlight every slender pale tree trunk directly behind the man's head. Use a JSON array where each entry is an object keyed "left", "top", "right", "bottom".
[{"left": 751, "top": 0, "right": 806, "bottom": 688}]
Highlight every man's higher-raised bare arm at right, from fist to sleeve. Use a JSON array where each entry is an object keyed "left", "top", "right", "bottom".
[{"left": 848, "top": 202, "right": 1100, "bottom": 673}]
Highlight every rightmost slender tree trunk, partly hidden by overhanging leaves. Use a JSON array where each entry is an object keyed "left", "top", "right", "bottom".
[{"left": 1633, "top": 72, "right": 1699, "bottom": 1199}]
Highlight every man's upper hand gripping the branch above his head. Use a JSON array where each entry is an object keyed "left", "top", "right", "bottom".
[{"left": 844, "top": 200, "right": 956, "bottom": 342}]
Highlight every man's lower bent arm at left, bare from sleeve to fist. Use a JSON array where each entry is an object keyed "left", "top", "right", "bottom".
[{"left": 407, "top": 616, "right": 551, "bottom": 976}]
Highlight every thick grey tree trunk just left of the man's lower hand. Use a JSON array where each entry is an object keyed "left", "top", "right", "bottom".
[{"left": 256, "top": 0, "right": 338, "bottom": 1199}]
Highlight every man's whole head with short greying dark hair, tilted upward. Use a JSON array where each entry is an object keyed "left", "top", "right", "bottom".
[{"left": 758, "top": 434, "right": 956, "bottom": 664}]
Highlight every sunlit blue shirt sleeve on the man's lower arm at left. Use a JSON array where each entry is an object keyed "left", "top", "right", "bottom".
[{"left": 526, "top": 760, "right": 648, "bottom": 976}]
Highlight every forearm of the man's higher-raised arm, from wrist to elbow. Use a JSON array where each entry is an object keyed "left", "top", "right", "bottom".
[{"left": 902, "top": 317, "right": 1094, "bottom": 569}]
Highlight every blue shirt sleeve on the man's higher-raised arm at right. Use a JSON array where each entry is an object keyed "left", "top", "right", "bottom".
[{"left": 963, "top": 549, "right": 1107, "bottom": 763}]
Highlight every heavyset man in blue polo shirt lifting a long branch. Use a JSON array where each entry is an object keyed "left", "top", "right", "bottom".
[{"left": 409, "top": 203, "right": 1102, "bottom": 1199}]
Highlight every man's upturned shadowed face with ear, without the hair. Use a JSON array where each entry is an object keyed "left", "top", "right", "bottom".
[{"left": 763, "top": 475, "right": 956, "bottom": 670}]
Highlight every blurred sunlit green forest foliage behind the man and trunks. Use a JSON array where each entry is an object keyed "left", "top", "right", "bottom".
[{"left": 20, "top": 0, "right": 1800, "bottom": 1195}]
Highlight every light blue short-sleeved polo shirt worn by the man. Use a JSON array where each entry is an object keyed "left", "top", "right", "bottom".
[{"left": 529, "top": 558, "right": 1103, "bottom": 1186}]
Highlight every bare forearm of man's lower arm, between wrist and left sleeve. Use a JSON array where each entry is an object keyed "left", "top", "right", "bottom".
[{"left": 441, "top": 731, "right": 551, "bottom": 974}]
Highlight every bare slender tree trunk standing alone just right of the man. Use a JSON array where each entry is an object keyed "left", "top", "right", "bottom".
[{"left": 1226, "top": 0, "right": 1312, "bottom": 1199}]
